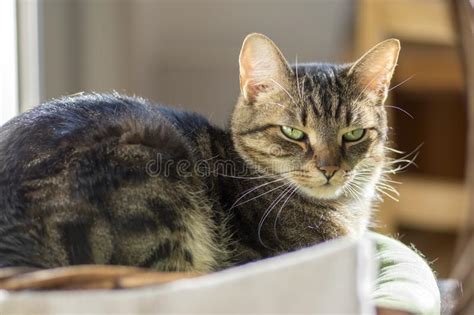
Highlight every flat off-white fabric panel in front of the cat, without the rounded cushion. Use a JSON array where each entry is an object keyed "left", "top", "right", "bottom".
[{"left": 0, "top": 239, "right": 375, "bottom": 315}]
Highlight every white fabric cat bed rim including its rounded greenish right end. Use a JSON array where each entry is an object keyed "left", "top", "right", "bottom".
[{"left": 0, "top": 233, "right": 440, "bottom": 315}]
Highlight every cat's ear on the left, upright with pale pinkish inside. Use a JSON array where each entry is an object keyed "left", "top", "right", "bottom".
[{"left": 239, "top": 33, "right": 292, "bottom": 101}]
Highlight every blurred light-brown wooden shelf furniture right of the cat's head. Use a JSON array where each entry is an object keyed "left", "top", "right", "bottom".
[{"left": 354, "top": 0, "right": 468, "bottom": 234}]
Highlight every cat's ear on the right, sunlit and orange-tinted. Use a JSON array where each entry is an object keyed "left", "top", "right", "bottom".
[{"left": 349, "top": 39, "right": 400, "bottom": 101}]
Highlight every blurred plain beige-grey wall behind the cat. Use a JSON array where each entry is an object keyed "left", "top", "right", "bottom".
[{"left": 45, "top": 0, "right": 354, "bottom": 124}]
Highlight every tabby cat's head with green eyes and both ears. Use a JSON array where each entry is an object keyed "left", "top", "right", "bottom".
[{"left": 231, "top": 34, "right": 400, "bottom": 199}]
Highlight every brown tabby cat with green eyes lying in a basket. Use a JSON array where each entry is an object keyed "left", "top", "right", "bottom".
[{"left": 0, "top": 33, "right": 400, "bottom": 272}]
